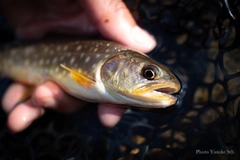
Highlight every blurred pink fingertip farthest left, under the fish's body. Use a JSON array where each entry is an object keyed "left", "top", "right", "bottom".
[{"left": 2, "top": 83, "right": 27, "bottom": 113}]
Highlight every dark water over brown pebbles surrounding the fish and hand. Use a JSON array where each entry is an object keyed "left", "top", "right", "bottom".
[{"left": 0, "top": 0, "right": 240, "bottom": 160}]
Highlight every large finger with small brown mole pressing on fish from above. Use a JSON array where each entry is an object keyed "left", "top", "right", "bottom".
[{"left": 83, "top": 0, "right": 156, "bottom": 52}]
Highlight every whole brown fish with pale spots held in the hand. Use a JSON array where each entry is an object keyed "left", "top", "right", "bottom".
[{"left": 0, "top": 40, "right": 181, "bottom": 108}]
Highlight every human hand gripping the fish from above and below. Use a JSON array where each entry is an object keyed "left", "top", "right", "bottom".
[{"left": 0, "top": 0, "right": 156, "bottom": 132}]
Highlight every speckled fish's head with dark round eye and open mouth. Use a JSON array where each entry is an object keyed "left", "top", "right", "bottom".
[{"left": 101, "top": 50, "right": 181, "bottom": 108}]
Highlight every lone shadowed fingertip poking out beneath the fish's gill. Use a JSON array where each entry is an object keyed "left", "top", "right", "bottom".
[{"left": 98, "top": 103, "right": 126, "bottom": 127}]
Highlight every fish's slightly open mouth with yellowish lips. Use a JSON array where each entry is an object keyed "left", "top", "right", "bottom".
[{"left": 133, "top": 82, "right": 181, "bottom": 108}]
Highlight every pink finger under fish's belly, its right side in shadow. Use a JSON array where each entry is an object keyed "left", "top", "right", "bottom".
[{"left": 33, "top": 81, "right": 86, "bottom": 113}]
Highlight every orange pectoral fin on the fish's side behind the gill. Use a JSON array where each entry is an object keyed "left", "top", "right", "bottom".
[{"left": 60, "top": 64, "right": 95, "bottom": 88}]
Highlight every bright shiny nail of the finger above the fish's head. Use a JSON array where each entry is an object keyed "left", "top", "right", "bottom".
[{"left": 131, "top": 26, "right": 157, "bottom": 51}]
